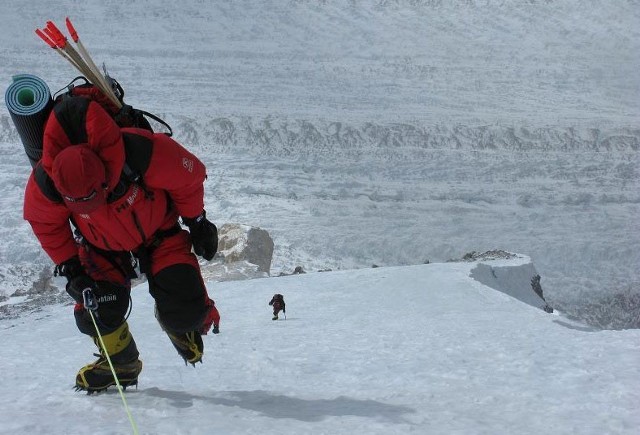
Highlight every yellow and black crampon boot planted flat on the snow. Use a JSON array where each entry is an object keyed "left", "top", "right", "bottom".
[{"left": 76, "top": 322, "right": 142, "bottom": 394}]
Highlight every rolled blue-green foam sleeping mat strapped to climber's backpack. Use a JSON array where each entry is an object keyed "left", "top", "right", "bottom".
[{"left": 4, "top": 74, "right": 53, "bottom": 167}]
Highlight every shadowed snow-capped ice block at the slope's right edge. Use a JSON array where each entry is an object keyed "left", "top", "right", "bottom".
[{"left": 463, "top": 251, "right": 553, "bottom": 313}]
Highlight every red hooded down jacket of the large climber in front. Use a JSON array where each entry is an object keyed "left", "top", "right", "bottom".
[{"left": 24, "top": 97, "right": 206, "bottom": 270}]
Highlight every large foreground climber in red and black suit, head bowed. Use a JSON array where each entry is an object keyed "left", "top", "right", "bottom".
[{"left": 24, "top": 97, "right": 220, "bottom": 392}]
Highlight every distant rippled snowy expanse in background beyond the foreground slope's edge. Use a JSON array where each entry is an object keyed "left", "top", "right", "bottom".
[{"left": 0, "top": 0, "right": 640, "bottom": 328}]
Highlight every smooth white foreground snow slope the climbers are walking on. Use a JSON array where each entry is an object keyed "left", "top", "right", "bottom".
[{"left": 0, "top": 257, "right": 640, "bottom": 435}]
